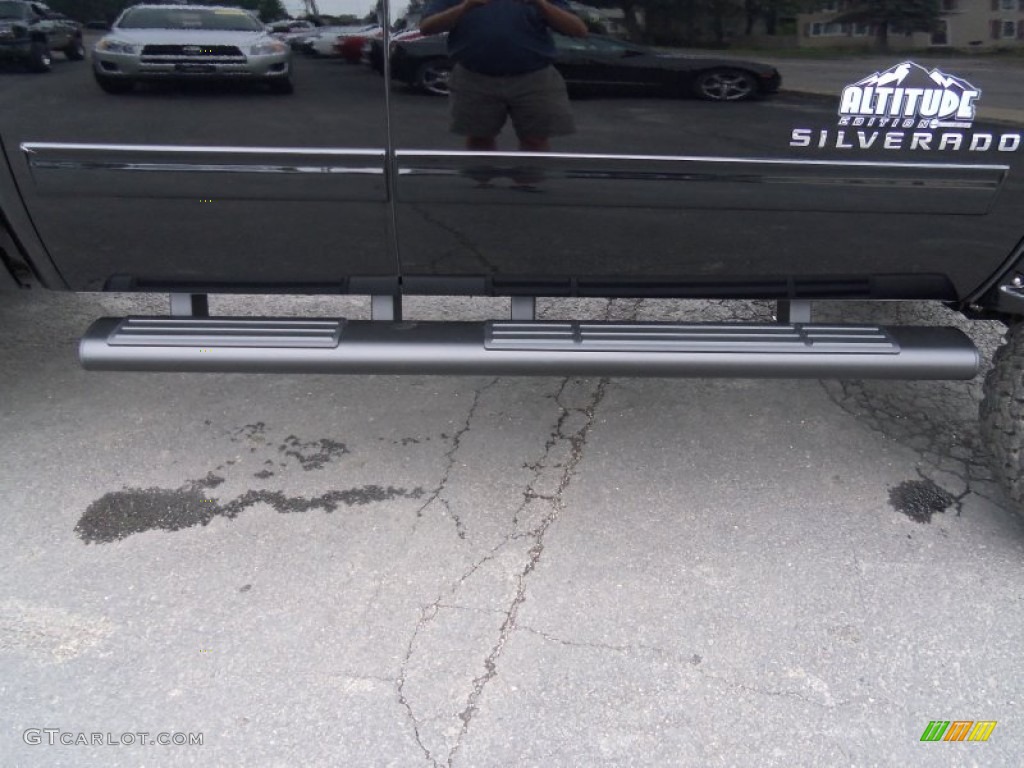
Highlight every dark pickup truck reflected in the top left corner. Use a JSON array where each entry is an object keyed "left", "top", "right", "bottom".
[{"left": 0, "top": 0, "right": 85, "bottom": 72}]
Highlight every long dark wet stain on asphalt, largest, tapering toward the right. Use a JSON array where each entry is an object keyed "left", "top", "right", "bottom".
[{"left": 75, "top": 480, "right": 424, "bottom": 544}]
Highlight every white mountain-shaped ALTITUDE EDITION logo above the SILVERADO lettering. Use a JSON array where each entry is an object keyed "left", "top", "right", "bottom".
[{"left": 839, "top": 61, "right": 981, "bottom": 128}]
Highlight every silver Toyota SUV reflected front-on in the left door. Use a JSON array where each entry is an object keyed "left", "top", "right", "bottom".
[{"left": 92, "top": 5, "right": 292, "bottom": 93}]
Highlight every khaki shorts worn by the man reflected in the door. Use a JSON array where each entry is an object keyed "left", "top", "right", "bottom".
[{"left": 449, "top": 65, "right": 575, "bottom": 138}]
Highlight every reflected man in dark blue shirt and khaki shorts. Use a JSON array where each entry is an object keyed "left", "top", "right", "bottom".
[{"left": 420, "top": 0, "right": 587, "bottom": 152}]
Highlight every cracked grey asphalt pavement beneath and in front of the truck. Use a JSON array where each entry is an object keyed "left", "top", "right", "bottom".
[{"left": 0, "top": 294, "right": 1024, "bottom": 768}]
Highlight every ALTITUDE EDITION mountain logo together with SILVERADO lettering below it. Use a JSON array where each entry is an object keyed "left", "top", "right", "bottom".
[{"left": 790, "top": 61, "right": 1022, "bottom": 152}]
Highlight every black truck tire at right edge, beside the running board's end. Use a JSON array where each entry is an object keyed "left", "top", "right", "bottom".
[{"left": 981, "top": 323, "right": 1024, "bottom": 505}]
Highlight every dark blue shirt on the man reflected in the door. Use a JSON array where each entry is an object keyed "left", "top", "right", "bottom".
[{"left": 423, "top": 0, "right": 568, "bottom": 76}]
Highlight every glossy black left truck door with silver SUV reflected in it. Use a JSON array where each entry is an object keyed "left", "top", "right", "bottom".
[{"left": 0, "top": 0, "right": 397, "bottom": 293}]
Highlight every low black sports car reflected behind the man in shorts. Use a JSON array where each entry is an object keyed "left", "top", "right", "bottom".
[{"left": 387, "top": 35, "right": 781, "bottom": 101}]
